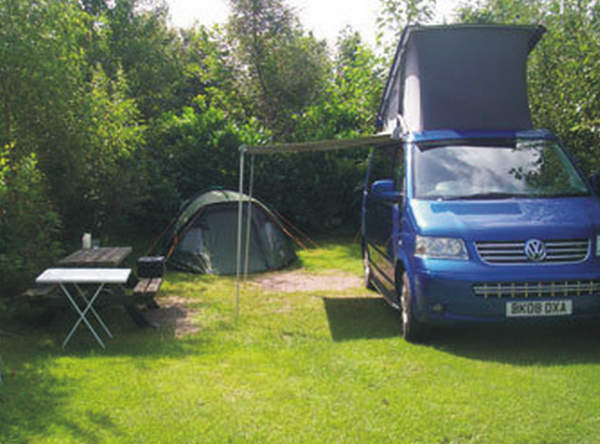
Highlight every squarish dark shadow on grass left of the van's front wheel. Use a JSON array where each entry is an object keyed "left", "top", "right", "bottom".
[{"left": 323, "top": 298, "right": 401, "bottom": 341}]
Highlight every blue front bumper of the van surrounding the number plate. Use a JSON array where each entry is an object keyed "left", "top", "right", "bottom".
[{"left": 411, "top": 260, "right": 600, "bottom": 324}]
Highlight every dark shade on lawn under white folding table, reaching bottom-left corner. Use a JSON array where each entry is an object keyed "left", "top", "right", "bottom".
[{"left": 0, "top": 294, "right": 219, "bottom": 443}]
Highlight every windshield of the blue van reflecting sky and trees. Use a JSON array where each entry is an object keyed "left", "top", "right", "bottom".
[{"left": 414, "top": 139, "right": 589, "bottom": 199}]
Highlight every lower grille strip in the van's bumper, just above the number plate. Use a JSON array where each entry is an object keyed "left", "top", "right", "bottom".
[{"left": 473, "top": 280, "right": 600, "bottom": 299}]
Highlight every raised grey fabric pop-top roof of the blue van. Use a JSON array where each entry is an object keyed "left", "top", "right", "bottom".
[{"left": 378, "top": 25, "right": 545, "bottom": 133}]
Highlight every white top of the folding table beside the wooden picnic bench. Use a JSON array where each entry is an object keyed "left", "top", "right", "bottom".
[{"left": 35, "top": 268, "right": 131, "bottom": 284}]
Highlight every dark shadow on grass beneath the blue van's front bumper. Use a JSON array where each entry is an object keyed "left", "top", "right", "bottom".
[{"left": 429, "top": 322, "right": 600, "bottom": 366}]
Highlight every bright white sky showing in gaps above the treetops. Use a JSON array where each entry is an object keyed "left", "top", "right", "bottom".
[{"left": 167, "top": 0, "right": 459, "bottom": 47}]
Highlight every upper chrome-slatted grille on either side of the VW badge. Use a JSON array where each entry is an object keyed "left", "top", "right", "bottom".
[{"left": 475, "top": 239, "right": 591, "bottom": 265}]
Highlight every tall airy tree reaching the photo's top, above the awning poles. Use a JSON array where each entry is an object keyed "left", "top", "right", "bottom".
[{"left": 229, "top": 0, "right": 329, "bottom": 138}]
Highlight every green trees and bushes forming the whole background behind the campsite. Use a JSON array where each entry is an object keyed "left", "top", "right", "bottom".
[{"left": 0, "top": 0, "right": 600, "bottom": 303}]
